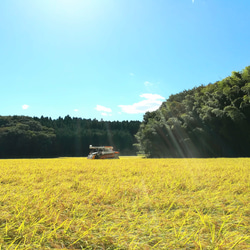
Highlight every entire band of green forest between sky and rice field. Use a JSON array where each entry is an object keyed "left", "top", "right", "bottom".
[{"left": 0, "top": 66, "right": 250, "bottom": 158}]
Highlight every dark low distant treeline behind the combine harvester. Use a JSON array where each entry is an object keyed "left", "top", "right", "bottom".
[{"left": 0, "top": 116, "right": 140, "bottom": 158}]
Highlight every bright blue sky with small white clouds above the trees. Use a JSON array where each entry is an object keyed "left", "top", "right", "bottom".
[{"left": 0, "top": 0, "right": 250, "bottom": 121}]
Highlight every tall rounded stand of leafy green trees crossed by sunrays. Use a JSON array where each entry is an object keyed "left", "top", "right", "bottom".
[{"left": 136, "top": 66, "right": 250, "bottom": 157}]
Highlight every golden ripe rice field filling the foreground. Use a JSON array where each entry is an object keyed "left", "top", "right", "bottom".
[{"left": 0, "top": 157, "right": 250, "bottom": 250}]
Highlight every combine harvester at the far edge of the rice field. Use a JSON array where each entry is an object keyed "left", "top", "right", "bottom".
[{"left": 88, "top": 145, "right": 119, "bottom": 159}]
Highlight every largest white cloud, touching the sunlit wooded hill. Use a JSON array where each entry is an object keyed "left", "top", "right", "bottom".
[{"left": 118, "top": 94, "right": 165, "bottom": 114}]
